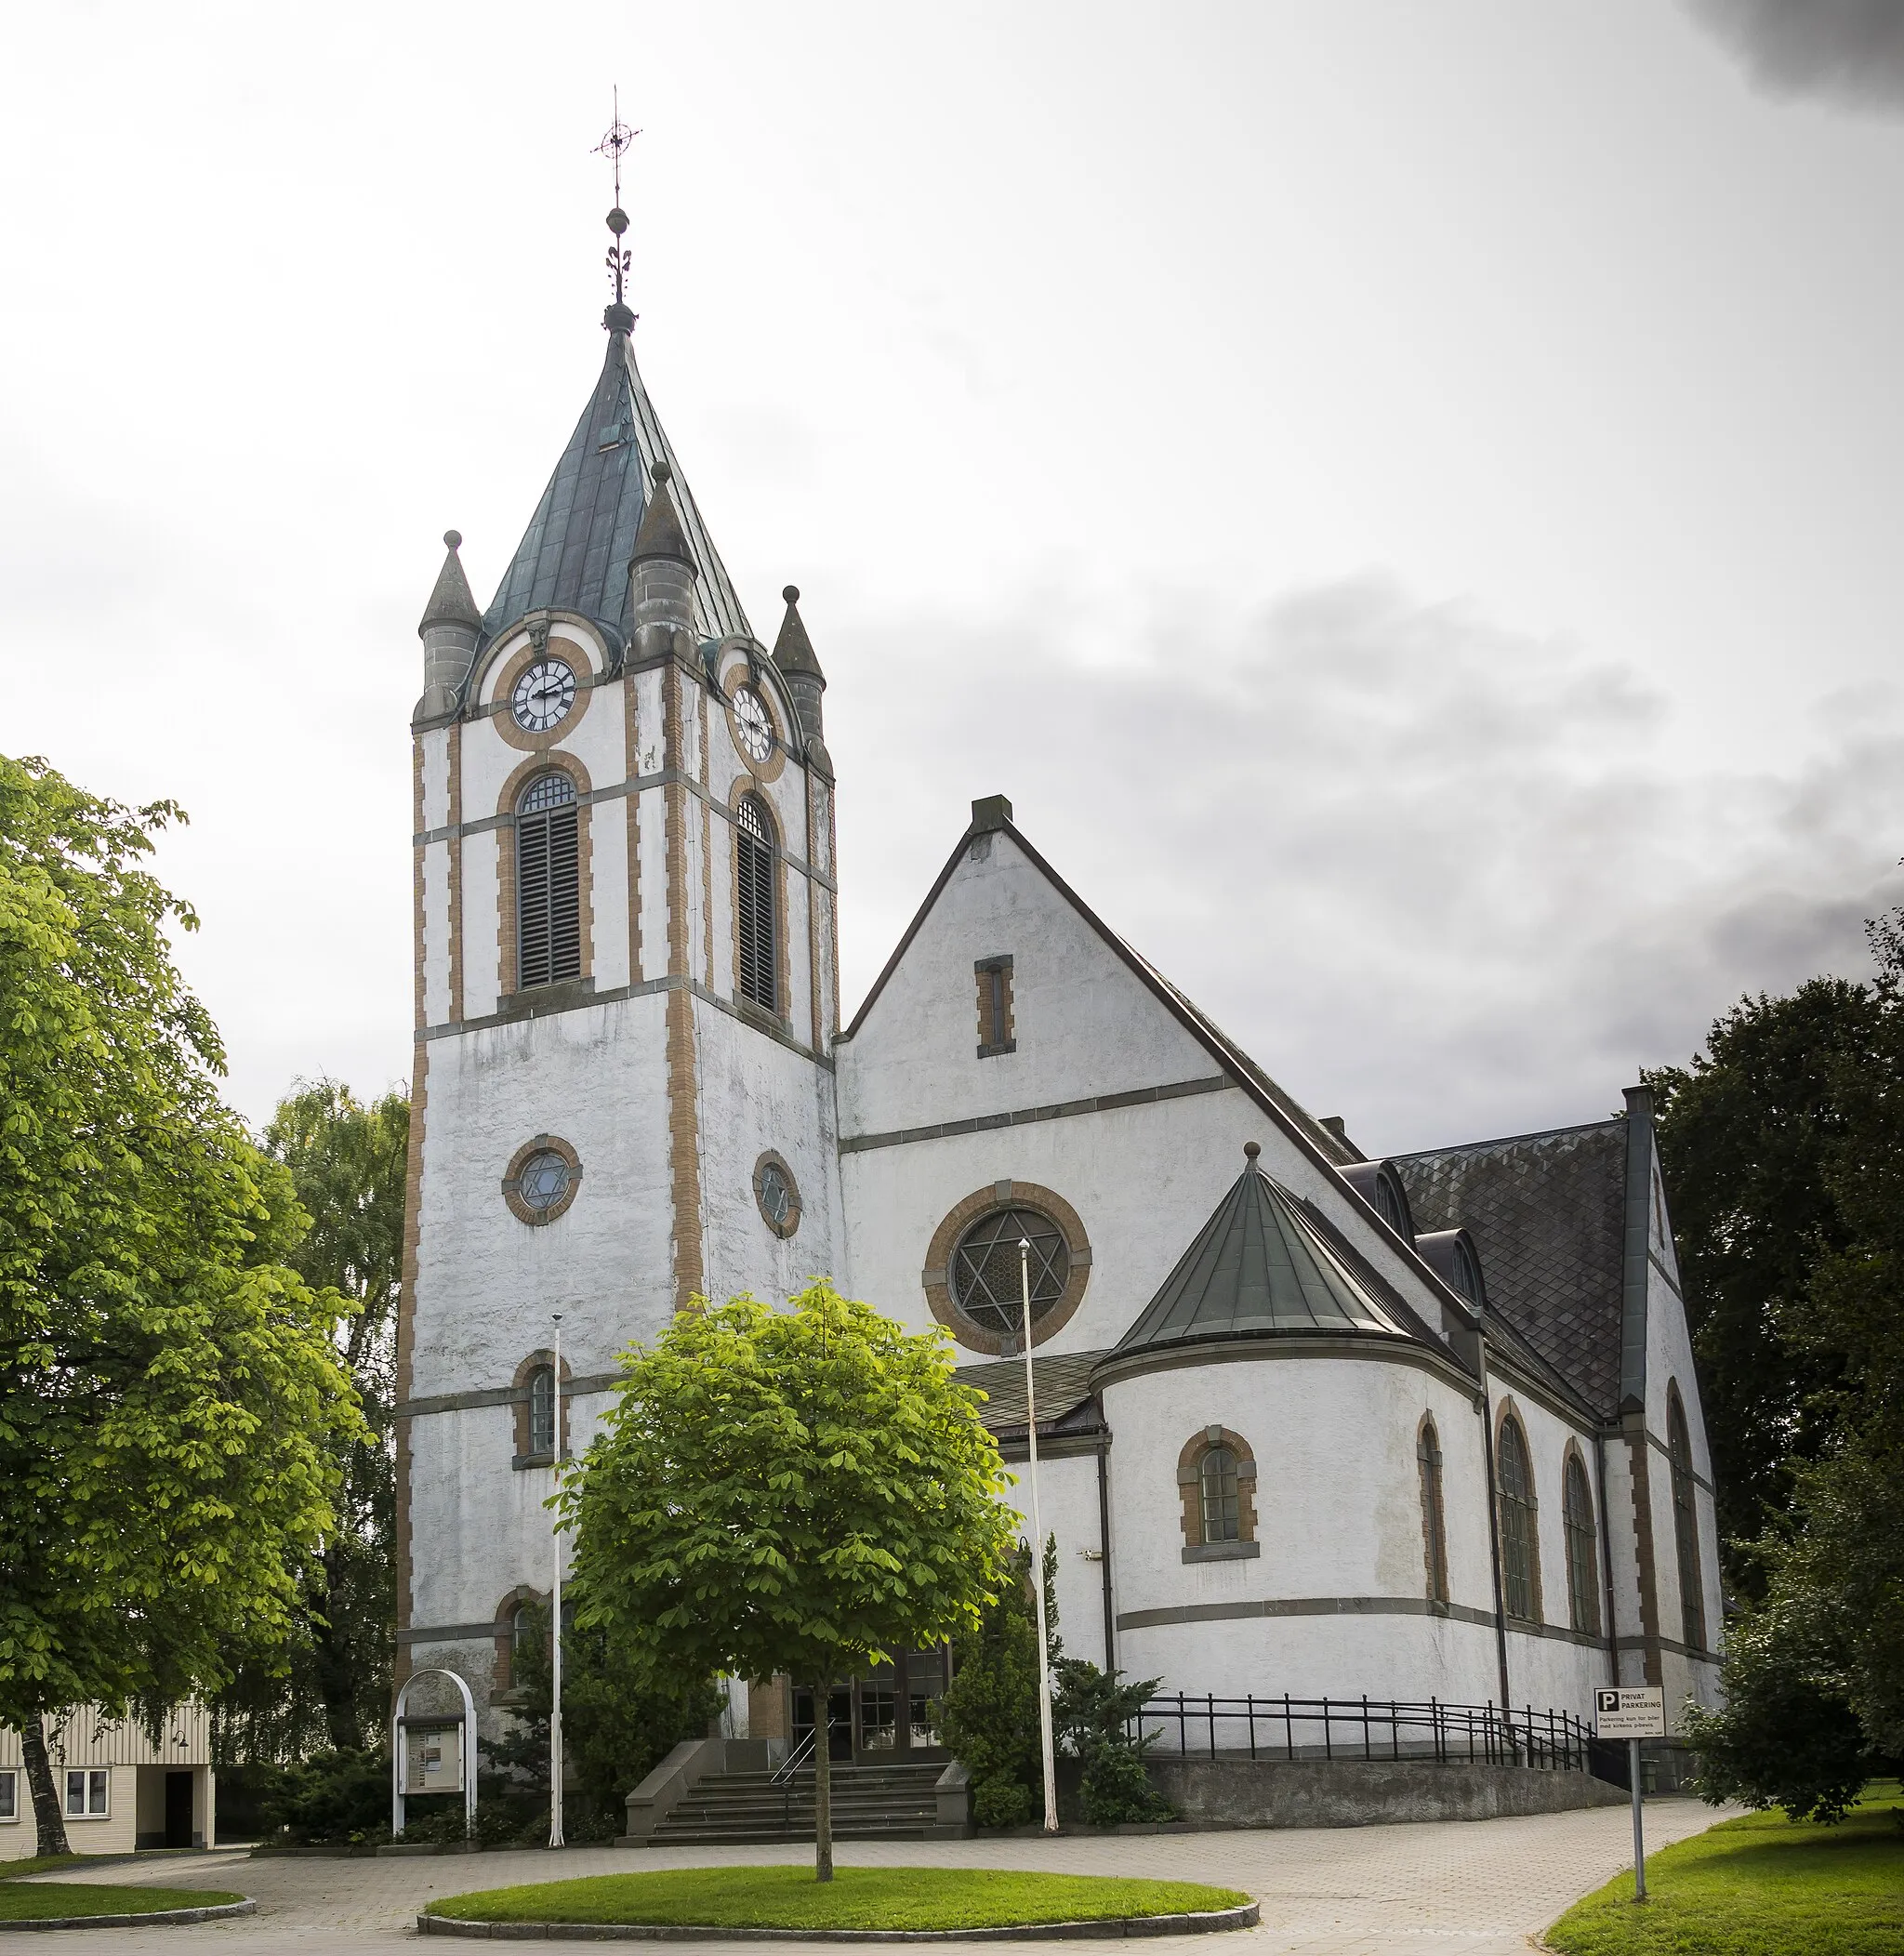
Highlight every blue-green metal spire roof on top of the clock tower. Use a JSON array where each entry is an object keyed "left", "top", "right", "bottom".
[{"left": 483, "top": 331, "right": 751, "bottom": 638}]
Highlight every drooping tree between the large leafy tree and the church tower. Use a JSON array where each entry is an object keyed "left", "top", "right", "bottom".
[{"left": 218, "top": 1079, "right": 409, "bottom": 1758}]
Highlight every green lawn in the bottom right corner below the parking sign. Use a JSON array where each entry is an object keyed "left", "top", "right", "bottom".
[{"left": 1546, "top": 1780, "right": 1904, "bottom": 1956}]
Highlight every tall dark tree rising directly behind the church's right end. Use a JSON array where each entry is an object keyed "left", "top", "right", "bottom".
[{"left": 1646, "top": 978, "right": 1883, "bottom": 1594}]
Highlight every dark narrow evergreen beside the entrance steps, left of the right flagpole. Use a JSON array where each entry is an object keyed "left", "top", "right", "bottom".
[{"left": 935, "top": 1536, "right": 1064, "bottom": 1827}]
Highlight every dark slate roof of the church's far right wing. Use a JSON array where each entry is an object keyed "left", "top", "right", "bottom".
[{"left": 1395, "top": 1121, "right": 1626, "bottom": 1416}]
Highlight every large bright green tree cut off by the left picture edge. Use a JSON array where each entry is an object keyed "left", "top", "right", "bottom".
[{"left": 0, "top": 760, "right": 360, "bottom": 1852}]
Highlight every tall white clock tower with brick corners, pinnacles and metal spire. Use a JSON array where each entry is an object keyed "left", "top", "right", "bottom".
[{"left": 397, "top": 191, "right": 841, "bottom": 1724}]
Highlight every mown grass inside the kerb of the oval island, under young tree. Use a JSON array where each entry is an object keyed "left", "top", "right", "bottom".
[{"left": 430, "top": 1866, "right": 1250, "bottom": 1929}]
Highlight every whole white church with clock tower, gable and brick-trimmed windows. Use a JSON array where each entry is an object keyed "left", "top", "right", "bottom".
[{"left": 397, "top": 211, "right": 1720, "bottom": 1783}]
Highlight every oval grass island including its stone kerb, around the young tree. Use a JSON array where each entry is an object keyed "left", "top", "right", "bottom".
[{"left": 416, "top": 1866, "right": 1256, "bottom": 1942}]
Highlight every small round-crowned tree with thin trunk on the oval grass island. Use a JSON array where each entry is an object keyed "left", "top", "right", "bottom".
[{"left": 562, "top": 1281, "right": 1012, "bottom": 1882}]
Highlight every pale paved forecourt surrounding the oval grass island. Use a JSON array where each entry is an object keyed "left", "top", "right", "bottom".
[{"left": 14, "top": 1800, "right": 1722, "bottom": 1956}]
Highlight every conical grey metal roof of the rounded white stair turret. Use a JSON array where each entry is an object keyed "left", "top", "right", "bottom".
[{"left": 1117, "top": 1143, "right": 1413, "bottom": 1354}]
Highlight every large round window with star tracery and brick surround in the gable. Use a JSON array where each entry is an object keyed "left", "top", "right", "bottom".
[{"left": 923, "top": 1182, "right": 1090, "bottom": 1352}]
